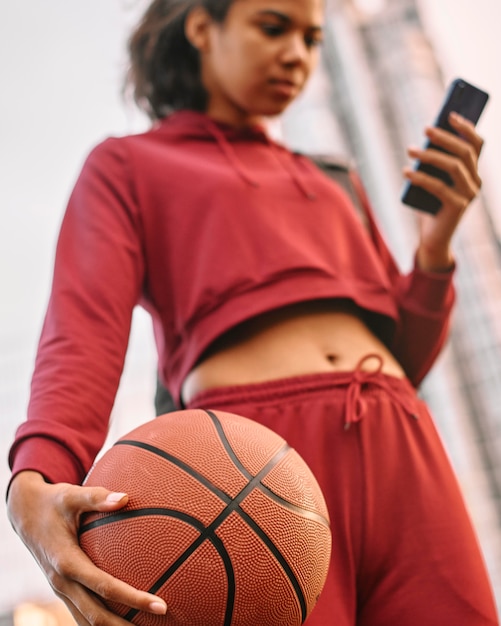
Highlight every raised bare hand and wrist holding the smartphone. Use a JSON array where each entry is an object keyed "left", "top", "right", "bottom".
[{"left": 404, "top": 113, "right": 484, "bottom": 272}]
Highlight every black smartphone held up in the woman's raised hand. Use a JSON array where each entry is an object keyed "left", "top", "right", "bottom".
[{"left": 401, "top": 78, "right": 489, "bottom": 214}]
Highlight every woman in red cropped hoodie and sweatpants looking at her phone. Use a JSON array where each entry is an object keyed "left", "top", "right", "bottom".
[{"left": 8, "top": 0, "right": 497, "bottom": 626}]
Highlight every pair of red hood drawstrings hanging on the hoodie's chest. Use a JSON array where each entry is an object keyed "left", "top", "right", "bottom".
[{"left": 200, "top": 112, "right": 316, "bottom": 200}]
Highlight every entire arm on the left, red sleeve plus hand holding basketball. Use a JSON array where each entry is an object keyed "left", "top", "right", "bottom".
[{"left": 8, "top": 140, "right": 165, "bottom": 626}]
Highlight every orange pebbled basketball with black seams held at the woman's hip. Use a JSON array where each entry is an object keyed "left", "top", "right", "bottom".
[{"left": 79, "top": 410, "right": 331, "bottom": 626}]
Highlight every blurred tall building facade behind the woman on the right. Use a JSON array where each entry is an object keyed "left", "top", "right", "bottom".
[{"left": 282, "top": 0, "right": 501, "bottom": 606}]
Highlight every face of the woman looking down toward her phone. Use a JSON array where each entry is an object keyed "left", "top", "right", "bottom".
[{"left": 193, "top": 0, "right": 324, "bottom": 126}]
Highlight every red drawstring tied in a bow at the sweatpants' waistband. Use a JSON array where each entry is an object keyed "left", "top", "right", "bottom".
[{"left": 344, "top": 354, "right": 418, "bottom": 430}]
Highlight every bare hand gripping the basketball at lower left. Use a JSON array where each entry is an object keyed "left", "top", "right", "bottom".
[{"left": 8, "top": 472, "right": 165, "bottom": 626}]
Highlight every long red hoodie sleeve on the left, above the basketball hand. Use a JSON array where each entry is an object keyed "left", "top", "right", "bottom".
[{"left": 10, "top": 139, "right": 145, "bottom": 484}]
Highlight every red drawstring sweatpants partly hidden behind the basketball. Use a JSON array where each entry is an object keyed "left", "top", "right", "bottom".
[{"left": 187, "top": 370, "right": 498, "bottom": 626}]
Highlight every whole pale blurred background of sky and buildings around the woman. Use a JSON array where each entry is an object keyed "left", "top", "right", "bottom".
[{"left": 0, "top": 0, "right": 501, "bottom": 626}]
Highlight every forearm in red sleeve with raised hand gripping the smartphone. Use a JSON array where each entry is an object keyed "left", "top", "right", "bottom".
[{"left": 387, "top": 114, "right": 483, "bottom": 385}]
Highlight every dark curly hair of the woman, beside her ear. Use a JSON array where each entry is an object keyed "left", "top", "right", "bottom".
[{"left": 127, "top": 0, "right": 235, "bottom": 119}]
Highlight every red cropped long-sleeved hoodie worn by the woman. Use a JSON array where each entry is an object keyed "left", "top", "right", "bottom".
[{"left": 10, "top": 111, "right": 454, "bottom": 483}]
